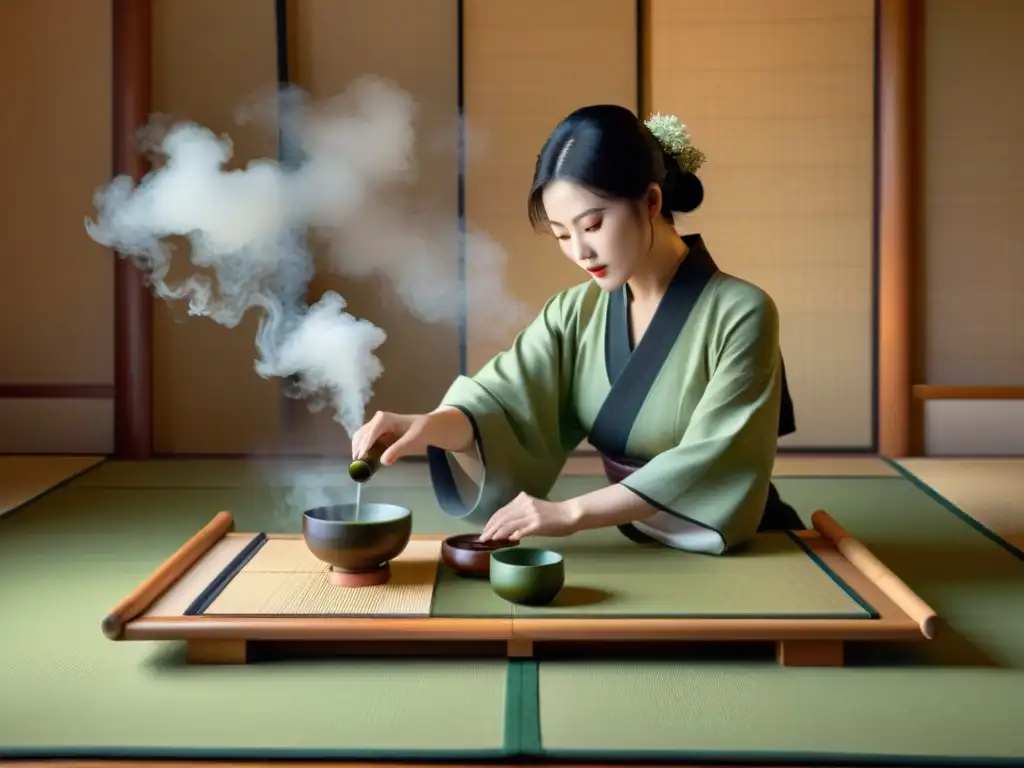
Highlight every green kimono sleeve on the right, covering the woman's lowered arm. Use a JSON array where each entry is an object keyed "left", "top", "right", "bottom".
[{"left": 622, "top": 294, "right": 781, "bottom": 554}]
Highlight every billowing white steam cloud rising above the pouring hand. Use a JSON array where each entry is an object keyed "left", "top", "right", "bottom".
[{"left": 86, "top": 77, "right": 524, "bottom": 436}]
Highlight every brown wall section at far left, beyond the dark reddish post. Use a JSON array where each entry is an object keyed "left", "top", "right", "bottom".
[{"left": 0, "top": 0, "right": 114, "bottom": 453}]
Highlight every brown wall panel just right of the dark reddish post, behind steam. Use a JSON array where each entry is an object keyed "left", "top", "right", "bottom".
[{"left": 153, "top": 0, "right": 282, "bottom": 454}]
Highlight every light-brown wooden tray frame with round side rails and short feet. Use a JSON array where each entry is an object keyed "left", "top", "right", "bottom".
[{"left": 101, "top": 510, "right": 938, "bottom": 667}]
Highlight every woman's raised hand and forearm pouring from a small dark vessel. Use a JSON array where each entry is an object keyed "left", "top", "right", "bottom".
[{"left": 352, "top": 408, "right": 473, "bottom": 466}]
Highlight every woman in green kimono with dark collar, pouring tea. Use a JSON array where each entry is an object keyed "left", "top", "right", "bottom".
[{"left": 352, "top": 105, "right": 802, "bottom": 554}]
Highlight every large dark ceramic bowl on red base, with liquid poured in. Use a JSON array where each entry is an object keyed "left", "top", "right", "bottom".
[{"left": 302, "top": 503, "right": 413, "bottom": 573}]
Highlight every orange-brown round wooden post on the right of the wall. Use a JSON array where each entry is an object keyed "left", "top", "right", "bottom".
[{"left": 878, "top": 0, "right": 921, "bottom": 459}]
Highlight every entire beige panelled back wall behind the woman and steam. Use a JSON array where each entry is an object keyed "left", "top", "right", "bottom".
[{"left": 0, "top": 0, "right": 1024, "bottom": 453}]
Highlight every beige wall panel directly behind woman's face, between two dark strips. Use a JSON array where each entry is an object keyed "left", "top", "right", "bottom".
[{"left": 463, "top": 0, "right": 637, "bottom": 373}]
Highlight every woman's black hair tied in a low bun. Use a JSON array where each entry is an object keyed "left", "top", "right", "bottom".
[{"left": 528, "top": 104, "right": 703, "bottom": 227}]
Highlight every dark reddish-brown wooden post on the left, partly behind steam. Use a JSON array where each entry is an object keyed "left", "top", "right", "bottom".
[{"left": 111, "top": 0, "right": 153, "bottom": 459}]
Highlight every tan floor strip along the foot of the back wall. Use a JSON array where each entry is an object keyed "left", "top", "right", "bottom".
[{"left": 0, "top": 455, "right": 1024, "bottom": 547}]
